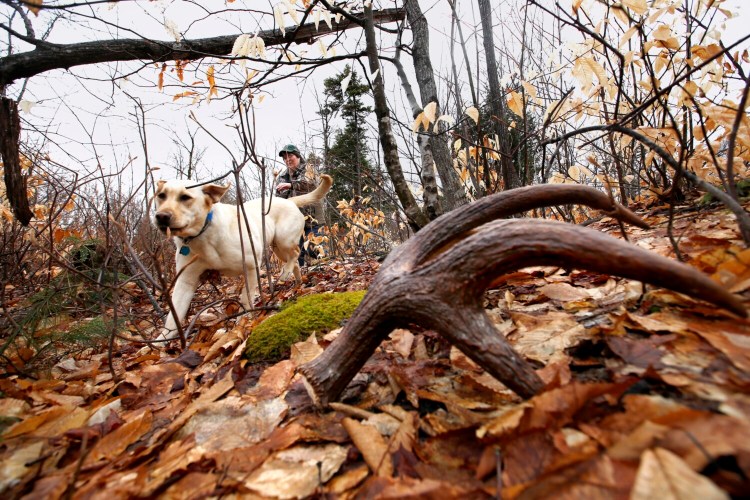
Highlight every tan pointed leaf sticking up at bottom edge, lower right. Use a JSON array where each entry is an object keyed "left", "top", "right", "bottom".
[{"left": 630, "top": 448, "right": 729, "bottom": 500}]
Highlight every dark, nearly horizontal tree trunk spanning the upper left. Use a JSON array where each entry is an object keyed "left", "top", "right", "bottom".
[{"left": 0, "top": 9, "right": 405, "bottom": 87}]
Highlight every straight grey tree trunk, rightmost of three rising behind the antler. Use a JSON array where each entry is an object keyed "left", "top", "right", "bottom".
[{"left": 478, "top": 0, "right": 521, "bottom": 189}]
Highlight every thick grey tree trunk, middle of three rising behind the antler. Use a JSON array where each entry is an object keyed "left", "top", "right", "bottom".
[{"left": 404, "top": 0, "right": 469, "bottom": 212}]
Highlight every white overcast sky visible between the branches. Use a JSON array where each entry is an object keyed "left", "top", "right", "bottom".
[{"left": 5, "top": 0, "right": 750, "bottom": 192}]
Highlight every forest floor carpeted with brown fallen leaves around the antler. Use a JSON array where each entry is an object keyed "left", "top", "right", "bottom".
[{"left": 0, "top": 200, "right": 750, "bottom": 500}]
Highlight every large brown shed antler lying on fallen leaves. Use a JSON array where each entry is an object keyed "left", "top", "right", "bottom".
[{"left": 300, "top": 185, "right": 746, "bottom": 405}]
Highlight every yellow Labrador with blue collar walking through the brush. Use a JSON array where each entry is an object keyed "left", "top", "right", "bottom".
[{"left": 154, "top": 175, "right": 333, "bottom": 339}]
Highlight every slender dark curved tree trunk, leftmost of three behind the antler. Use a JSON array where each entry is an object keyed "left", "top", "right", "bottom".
[{"left": 364, "top": 7, "right": 430, "bottom": 231}]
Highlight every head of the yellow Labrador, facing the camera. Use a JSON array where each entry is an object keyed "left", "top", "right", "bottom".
[{"left": 154, "top": 181, "right": 229, "bottom": 238}]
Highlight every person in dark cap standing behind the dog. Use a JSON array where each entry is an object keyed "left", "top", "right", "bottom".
[{"left": 276, "top": 144, "right": 324, "bottom": 266}]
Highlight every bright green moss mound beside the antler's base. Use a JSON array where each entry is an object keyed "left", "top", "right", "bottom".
[{"left": 245, "top": 291, "right": 365, "bottom": 363}]
